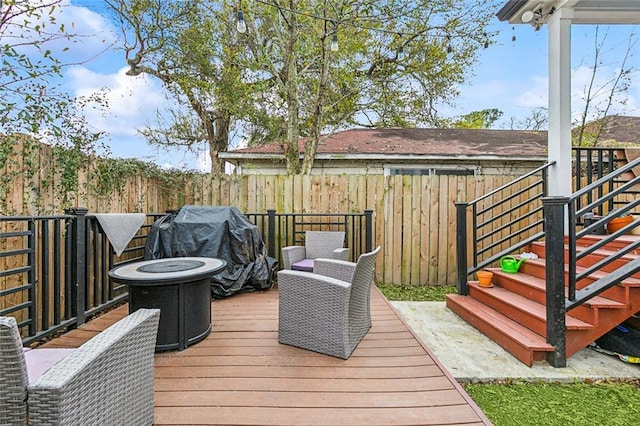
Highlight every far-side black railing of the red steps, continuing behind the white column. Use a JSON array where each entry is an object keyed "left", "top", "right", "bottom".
[{"left": 456, "top": 147, "right": 640, "bottom": 294}]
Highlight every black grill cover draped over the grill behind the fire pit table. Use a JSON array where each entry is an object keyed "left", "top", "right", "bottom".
[{"left": 145, "top": 205, "right": 277, "bottom": 299}]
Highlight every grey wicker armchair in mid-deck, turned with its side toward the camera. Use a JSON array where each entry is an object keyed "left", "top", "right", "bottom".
[{"left": 278, "top": 247, "right": 380, "bottom": 359}]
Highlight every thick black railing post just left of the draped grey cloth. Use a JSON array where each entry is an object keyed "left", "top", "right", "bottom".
[{"left": 65, "top": 207, "right": 89, "bottom": 326}]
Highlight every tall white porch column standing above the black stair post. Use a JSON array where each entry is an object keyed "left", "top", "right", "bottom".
[{"left": 547, "top": 7, "right": 573, "bottom": 196}]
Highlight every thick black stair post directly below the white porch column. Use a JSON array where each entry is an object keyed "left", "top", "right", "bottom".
[{"left": 542, "top": 197, "right": 569, "bottom": 367}]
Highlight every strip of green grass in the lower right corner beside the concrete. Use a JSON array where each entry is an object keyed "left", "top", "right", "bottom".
[{"left": 465, "top": 382, "right": 640, "bottom": 426}]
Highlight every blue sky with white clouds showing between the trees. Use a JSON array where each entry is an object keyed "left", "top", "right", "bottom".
[{"left": 37, "top": 0, "right": 640, "bottom": 170}]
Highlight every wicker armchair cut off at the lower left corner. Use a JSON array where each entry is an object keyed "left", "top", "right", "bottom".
[{"left": 0, "top": 309, "right": 160, "bottom": 425}]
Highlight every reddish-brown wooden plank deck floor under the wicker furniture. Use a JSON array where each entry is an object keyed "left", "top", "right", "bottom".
[{"left": 46, "top": 289, "right": 490, "bottom": 425}]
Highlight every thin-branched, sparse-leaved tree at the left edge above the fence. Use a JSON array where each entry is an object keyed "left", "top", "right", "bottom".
[{"left": 0, "top": 0, "right": 102, "bottom": 214}]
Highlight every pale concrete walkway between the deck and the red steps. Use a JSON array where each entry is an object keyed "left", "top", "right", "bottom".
[{"left": 391, "top": 302, "right": 640, "bottom": 382}]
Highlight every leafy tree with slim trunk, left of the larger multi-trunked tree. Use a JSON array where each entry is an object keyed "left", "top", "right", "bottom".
[{"left": 106, "top": 0, "right": 248, "bottom": 174}]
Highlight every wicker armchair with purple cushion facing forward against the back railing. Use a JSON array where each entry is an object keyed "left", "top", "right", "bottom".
[{"left": 282, "top": 231, "right": 349, "bottom": 272}]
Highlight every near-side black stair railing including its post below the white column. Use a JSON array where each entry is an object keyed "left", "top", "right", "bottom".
[{"left": 543, "top": 158, "right": 640, "bottom": 367}]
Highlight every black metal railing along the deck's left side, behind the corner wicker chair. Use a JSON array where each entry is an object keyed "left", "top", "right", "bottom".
[{"left": 0, "top": 209, "right": 157, "bottom": 344}]
